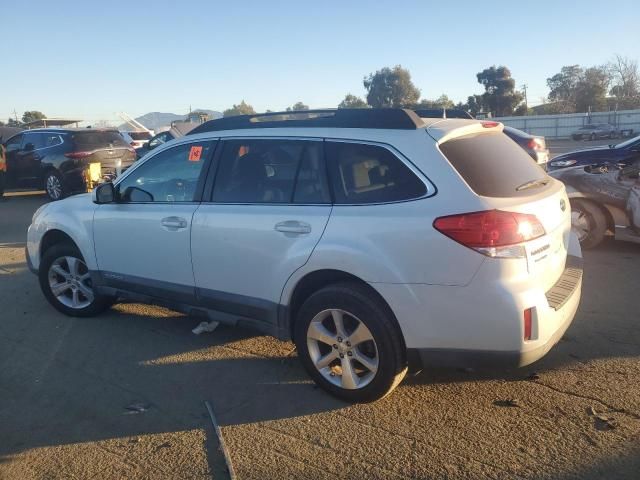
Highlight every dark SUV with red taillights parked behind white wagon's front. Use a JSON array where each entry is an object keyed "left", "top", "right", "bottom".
[{"left": 4, "top": 128, "right": 136, "bottom": 200}]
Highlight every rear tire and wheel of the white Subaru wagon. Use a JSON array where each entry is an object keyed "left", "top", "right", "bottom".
[{"left": 294, "top": 283, "right": 407, "bottom": 402}]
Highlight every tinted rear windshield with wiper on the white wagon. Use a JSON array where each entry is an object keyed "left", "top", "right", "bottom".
[{"left": 440, "top": 132, "right": 550, "bottom": 197}]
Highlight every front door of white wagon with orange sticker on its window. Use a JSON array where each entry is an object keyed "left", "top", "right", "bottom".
[{"left": 93, "top": 141, "right": 216, "bottom": 303}]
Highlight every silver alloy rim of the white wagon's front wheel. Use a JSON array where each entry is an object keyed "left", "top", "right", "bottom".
[{"left": 48, "top": 256, "right": 95, "bottom": 310}]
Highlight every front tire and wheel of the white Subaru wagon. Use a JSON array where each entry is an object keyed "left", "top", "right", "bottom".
[{"left": 38, "top": 243, "right": 113, "bottom": 317}]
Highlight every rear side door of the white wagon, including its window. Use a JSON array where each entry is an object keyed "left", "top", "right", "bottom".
[{"left": 191, "top": 139, "right": 332, "bottom": 328}]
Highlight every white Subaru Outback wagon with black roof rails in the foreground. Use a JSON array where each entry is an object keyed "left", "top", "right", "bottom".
[{"left": 27, "top": 109, "right": 582, "bottom": 401}]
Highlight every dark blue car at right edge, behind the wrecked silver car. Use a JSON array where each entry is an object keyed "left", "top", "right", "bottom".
[{"left": 548, "top": 135, "right": 640, "bottom": 171}]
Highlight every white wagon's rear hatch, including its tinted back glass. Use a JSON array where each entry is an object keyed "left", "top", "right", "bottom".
[{"left": 436, "top": 122, "right": 571, "bottom": 290}]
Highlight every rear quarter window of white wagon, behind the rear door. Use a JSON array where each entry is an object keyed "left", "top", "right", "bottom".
[{"left": 325, "top": 142, "right": 427, "bottom": 204}]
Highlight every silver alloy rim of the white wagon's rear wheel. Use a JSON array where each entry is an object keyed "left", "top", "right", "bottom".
[{"left": 307, "top": 309, "right": 379, "bottom": 390}]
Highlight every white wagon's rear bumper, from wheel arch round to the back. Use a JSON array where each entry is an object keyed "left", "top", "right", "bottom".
[{"left": 372, "top": 233, "right": 582, "bottom": 367}]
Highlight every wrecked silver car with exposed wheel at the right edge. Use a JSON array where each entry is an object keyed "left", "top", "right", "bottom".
[{"left": 551, "top": 161, "right": 640, "bottom": 248}]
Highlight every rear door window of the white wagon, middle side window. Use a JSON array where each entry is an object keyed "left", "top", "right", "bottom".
[{"left": 213, "top": 139, "right": 330, "bottom": 203}]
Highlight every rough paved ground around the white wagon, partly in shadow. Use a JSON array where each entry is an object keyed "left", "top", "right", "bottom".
[{"left": 0, "top": 194, "right": 640, "bottom": 480}]
